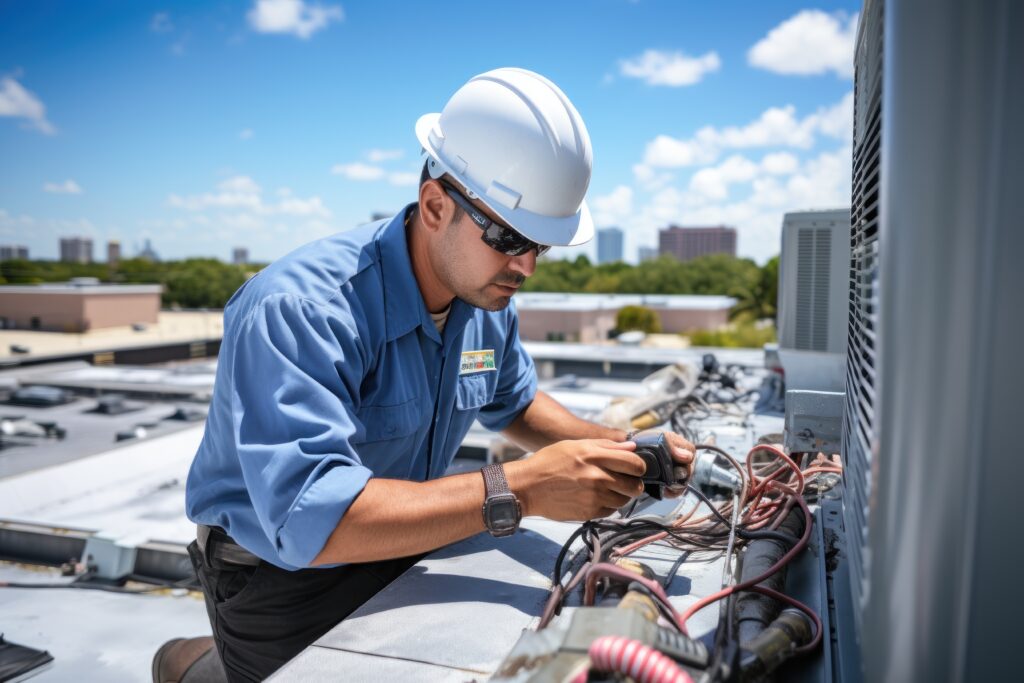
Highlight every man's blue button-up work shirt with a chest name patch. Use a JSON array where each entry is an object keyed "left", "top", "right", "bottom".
[{"left": 185, "top": 205, "right": 537, "bottom": 569}]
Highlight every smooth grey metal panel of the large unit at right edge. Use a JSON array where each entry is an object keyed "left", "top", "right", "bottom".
[{"left": 864, "top": 0, "right": 1024, "bottom": 681}]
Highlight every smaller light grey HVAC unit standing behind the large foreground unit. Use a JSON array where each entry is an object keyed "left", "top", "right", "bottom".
[{"left": 778, "top": 209, "right": 850, "bottom": 391}]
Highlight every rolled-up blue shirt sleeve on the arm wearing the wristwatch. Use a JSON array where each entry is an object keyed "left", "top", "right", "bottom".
[{"left": 231, "top": 295, "right": 372, "bottom": 566}]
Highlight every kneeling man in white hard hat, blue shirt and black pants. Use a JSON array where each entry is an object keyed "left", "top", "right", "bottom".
[{"left": 155, "top": 69, "right": 692, "bottom": 681}]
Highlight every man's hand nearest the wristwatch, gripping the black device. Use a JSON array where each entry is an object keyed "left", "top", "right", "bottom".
[{"left": 505, "top": 439, "right": 643, "bottom": 521}]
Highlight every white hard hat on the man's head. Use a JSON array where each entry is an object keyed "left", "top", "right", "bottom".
[{"left": 416, "top": 69, "right": 594, "bottom": 246}]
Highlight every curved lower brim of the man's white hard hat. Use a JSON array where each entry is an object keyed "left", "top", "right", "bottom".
[{"left": 416, "top": 114, "right": 594, "bottom": 247}]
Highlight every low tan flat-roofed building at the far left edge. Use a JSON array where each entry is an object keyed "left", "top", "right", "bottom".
[{"left": 0, "top": 278, "right": 163, "bottom": 332}]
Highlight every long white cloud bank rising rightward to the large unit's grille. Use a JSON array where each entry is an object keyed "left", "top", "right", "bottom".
[{"left": 643, "top": 93, "right": 853, "bottom": 168}]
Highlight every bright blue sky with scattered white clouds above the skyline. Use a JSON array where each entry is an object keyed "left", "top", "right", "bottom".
[{"left": 0, "top": 0, "right": 860, "bottom": 261}]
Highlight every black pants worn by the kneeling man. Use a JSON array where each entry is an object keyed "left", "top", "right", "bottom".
[{"left": 188, "top": 542, "right": 421, "bottom": 683}]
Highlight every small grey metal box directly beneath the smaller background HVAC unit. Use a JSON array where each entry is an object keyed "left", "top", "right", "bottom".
[{"left": 782, "top": 389, "right": 846, "bottom": 456}]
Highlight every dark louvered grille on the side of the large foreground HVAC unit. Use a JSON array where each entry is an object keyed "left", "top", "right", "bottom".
[{"left": 843, "top": 0, "right": 884, "bottom": 631}]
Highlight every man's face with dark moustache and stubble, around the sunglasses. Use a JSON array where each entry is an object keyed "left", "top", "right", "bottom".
[{"left": 437, "top": 198, "right": 537, "bottom": 310}]
